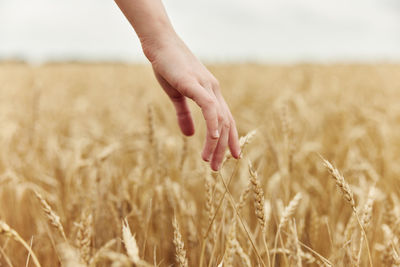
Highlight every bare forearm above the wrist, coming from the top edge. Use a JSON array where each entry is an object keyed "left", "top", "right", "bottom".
[{"left": 115, "top": 0, "right": 177, "bottom": 57}]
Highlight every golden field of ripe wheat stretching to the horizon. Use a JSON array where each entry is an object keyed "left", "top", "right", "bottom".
[{"left": 0, "top": 63, "right": 400, "bottom": 266}]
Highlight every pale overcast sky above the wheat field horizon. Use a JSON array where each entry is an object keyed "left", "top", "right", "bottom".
[{"left": 0, "top": 0, "right": 400, "bottom": 63}]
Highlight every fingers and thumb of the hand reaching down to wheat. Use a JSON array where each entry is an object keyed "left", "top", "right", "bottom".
[{"left": 155, "top": 67, "right": 240, "bottom": 171}]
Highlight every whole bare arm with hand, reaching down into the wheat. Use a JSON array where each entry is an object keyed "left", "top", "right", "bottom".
[{"left": 115, "top": 0, "right": 241, "bottom": 171}]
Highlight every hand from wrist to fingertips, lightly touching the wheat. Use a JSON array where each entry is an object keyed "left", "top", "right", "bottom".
[{"left": 141, "top": 34, "right": 240, "bottom": 171}]
